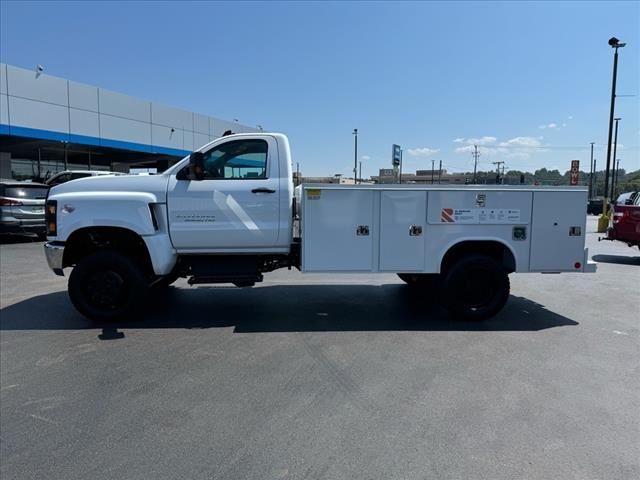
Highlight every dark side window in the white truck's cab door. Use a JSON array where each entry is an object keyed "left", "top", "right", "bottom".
[{"left": 204, "top": 140, "right": 267, "bottom": 180}]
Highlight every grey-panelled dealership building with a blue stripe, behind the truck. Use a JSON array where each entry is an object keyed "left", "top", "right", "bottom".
[{"left": 0, "top": 64, "right": 258, "bottom": 181}]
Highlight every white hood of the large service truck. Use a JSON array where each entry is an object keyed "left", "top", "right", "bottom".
[{"left": 49, "top": 175, "right": 170, "bottom": 203}]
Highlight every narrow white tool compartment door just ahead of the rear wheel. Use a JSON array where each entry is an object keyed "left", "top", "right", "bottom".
[{"left": 380, "top": 191, "right": 427, "bottom": 272}]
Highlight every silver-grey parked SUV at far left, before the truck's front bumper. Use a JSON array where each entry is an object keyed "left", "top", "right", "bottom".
[{"left": 0, "top": 180, "right": 49, "bottom": 237}]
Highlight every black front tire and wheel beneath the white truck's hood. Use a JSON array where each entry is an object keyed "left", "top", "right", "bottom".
[{"left": 68, "top": 250, "right": 148, "bottom": 321}]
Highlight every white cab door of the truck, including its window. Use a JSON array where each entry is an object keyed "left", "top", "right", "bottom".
[{"left": 167, "top": 137, "right": 280, "bottom": 251}]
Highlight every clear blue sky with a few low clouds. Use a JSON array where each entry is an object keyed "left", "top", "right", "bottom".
[{"left": 0, "top": 0, "right": 640, "bottom": 177}]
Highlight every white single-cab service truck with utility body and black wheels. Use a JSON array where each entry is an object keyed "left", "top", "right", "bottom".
[{"left": 44, "top": 132, "right": 595, "bottom": 321}]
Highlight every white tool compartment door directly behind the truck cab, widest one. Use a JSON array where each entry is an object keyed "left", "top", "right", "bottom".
[{"left": 302, "top": 188, "right": 376, "bottom": 272}]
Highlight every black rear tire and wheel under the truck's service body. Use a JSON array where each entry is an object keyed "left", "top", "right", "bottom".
[{"left": 441, "top": 255, "right": 510, "bottom": 320}]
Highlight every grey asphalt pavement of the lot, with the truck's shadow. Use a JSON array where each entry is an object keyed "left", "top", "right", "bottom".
[{"left": 0, "top": 217, "right": 640, "bottom": 480}]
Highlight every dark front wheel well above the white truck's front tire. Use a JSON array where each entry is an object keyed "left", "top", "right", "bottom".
[{"left": 62, "top": 227, "right": 153, "bottom": 273}]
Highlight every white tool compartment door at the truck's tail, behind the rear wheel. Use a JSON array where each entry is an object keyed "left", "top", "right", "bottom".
[{"left": 530, "top": 191, "right": 587, "bottom": 272}]
